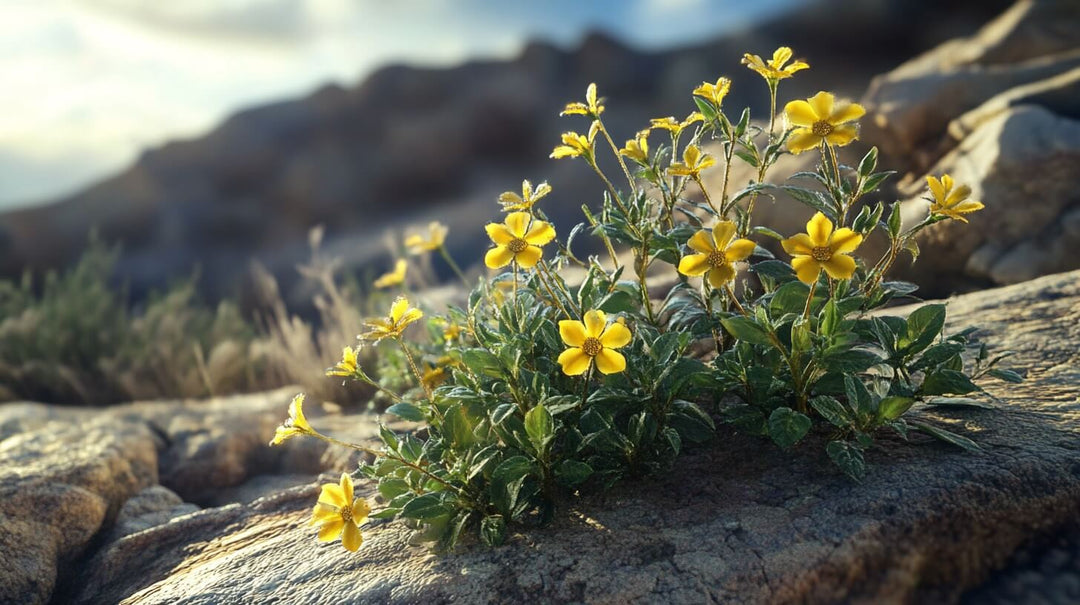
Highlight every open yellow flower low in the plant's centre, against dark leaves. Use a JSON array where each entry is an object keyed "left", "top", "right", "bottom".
[{"left": 558, "top": 311, "right": 631, "bottom": 376}]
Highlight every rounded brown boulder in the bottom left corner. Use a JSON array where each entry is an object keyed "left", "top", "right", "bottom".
[{"left": 0, "top": 408, "right": 158, "bottom": 603}]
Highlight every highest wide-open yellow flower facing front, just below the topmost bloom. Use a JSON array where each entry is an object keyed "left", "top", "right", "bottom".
[{"left": 784, "top": 91, "right": 866, "bottom": 153}]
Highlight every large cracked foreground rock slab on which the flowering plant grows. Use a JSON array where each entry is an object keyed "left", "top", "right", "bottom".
[{"left": 65, "top": 272, "right": 1080, "bottom": 604}]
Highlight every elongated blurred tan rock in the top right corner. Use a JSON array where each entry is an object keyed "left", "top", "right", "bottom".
[{"left": 863, "top": 0, "right": 1080, "bottom": 170}]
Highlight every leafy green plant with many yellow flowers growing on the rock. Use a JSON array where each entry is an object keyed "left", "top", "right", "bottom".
[{"left": 273, "top": 48, "right": 1020, "bottom": 550}]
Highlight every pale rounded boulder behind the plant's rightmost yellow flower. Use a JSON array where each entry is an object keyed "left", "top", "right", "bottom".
[{"left": 896, "top": 105, "right": 1080, "bottom": 292}]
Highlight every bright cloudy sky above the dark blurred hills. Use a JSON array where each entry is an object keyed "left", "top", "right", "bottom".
[{"left": 0, "top": 0, "right": 799, "bottom": 211}]
